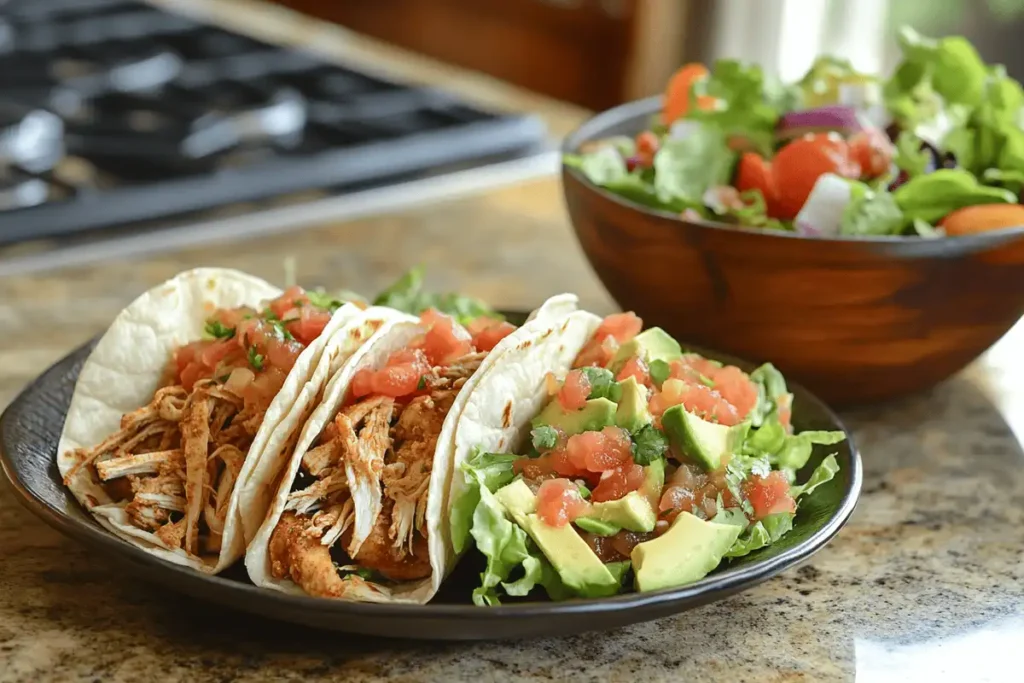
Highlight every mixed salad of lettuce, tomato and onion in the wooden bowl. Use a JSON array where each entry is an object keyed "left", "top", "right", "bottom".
[{"left": 564, "top": 28, "right": 1024, "bottom": 238}]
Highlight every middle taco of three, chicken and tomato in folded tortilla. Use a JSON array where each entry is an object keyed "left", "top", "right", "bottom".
[{"left": 246, "top": 295, "right": 577, "bottom": 603}]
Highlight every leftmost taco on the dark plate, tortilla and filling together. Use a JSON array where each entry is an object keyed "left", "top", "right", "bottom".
[{"left": 57, "top": 268, "right": 400, "bottom": 573}]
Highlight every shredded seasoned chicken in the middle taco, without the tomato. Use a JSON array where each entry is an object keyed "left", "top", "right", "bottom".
[{"left": 269, "top": 353, "right": 484, "bottom": 597}]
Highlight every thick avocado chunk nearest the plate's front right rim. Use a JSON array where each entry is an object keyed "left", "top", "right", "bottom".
[{"left": 630, "top": 512, "right": 742, "bottom": 592}]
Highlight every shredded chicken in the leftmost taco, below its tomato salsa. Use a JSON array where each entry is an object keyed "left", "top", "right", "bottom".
[{"left": 65, "top": 380, "right": 259, "bottom": 557}]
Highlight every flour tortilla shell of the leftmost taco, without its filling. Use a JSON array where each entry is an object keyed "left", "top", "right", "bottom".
[{"left": 57, "top": 268, "right": 374, "bottom": 573}]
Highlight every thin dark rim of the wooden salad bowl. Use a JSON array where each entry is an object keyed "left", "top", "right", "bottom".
[{"left": 559, "top": 95, "right": 1024, "bottom": 249}]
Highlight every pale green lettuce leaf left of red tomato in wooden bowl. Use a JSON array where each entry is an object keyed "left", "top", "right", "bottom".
[{"left": 654, "top": 125, "right": 736, "bottom": 207}]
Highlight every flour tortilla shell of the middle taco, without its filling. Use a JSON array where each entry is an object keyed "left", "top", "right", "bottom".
[{"left": 246, "top": 294, "right": 579, "bottom": 604}]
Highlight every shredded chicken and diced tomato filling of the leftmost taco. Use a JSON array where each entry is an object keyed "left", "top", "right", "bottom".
[{"left": 65, "top": 287, "right": 356, "bottom": 557}]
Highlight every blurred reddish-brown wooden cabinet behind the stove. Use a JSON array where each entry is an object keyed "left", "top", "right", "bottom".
[{"left": 266, "top": 0, "right": 688, "bottom": 110}]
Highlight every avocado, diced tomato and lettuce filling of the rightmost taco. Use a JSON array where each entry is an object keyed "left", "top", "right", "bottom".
[{"left": 452, "top": 312, "right": 846, "bottom": 605}]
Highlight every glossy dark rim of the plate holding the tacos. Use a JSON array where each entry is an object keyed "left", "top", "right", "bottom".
[{"left": 0, "top": 325, "right": 864, "bottom": 624}]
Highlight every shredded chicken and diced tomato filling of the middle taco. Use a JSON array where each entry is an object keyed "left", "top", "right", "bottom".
[{"left": 268, "top": 309, "right": 515, "bottom": 597}]
